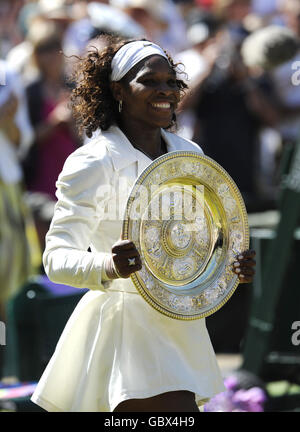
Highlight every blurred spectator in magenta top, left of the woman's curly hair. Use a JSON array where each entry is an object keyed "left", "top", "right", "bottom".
[{"left": 24, "top": 26, "right": 80, "bottom": 199}]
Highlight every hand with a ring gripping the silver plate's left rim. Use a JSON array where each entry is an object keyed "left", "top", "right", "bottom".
[{"left": 107, "top": 240, "right": 142, "bottom": 278}]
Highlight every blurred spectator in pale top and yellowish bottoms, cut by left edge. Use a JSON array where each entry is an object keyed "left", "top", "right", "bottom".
[{"left": 0, "top": 61, "right": 32, "bottom": 320}]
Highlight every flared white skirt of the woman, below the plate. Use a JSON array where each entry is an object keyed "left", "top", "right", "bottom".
[{"left": 31, "top": 279, "right": 225, "bottom": 412}]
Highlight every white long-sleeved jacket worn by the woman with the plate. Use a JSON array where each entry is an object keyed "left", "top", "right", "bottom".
[{"left": 43, "top": 126, "right": 203, "bottom": 290}]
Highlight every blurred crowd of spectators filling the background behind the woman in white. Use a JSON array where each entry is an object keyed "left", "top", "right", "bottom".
[{"left": 0, "top": 0, "right": 300, "bottom": 340}]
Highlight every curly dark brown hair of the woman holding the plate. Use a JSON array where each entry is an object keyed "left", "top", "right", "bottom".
[{"left": 71, "top": 35, "right": 187, "bottom": 138}]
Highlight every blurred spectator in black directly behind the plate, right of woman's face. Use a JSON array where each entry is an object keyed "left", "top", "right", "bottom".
[{"left": 178, "top": 26, "right": 277, "bottom": 212}]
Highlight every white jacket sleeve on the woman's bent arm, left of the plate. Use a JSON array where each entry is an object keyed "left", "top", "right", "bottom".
[{"left": 43, "top": 146, "right": 112, "bottom": 290}]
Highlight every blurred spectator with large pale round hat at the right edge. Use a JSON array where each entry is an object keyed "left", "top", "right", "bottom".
[{"left": 242, "top": 25, "right": 300, "bottom": 202}]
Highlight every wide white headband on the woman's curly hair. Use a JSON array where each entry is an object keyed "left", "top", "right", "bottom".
[{"left": 110, "top": 41, "right": 169, "bottom": 81}]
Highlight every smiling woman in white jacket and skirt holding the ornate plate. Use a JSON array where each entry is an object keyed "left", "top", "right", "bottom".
[{"left": 32, "top": 36, "right": 254, "bottom": 412}]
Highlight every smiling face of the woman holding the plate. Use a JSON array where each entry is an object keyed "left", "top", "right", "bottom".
[{"left": 110, "top": 55, "right": 180, "bottom": 128}]
